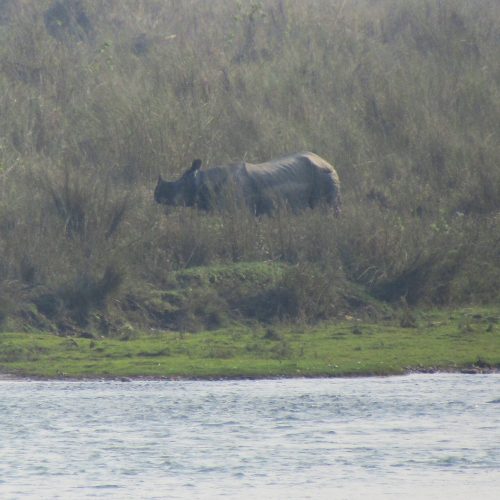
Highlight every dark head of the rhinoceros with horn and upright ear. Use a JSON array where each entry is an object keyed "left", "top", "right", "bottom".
[{"left": 154, "top": 160, "right": 201, "bottom": 207}]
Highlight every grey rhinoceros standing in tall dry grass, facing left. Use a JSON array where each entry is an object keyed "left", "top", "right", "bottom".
[{"left": 154, "top": 152, "right": 340, "bottom": 216}]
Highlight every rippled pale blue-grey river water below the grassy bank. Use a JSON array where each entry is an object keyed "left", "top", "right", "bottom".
[{"left": 0, "top": 374, "right": 500, "bottom": 500}]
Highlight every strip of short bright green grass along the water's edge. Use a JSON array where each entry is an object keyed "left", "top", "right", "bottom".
[{"left": 0, "top": 309, "right": 500, "bottom": 378}]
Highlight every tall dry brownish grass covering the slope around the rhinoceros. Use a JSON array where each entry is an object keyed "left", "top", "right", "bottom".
[{"left": 0, "top": 0, "right": 500, "bottom": 340}]
